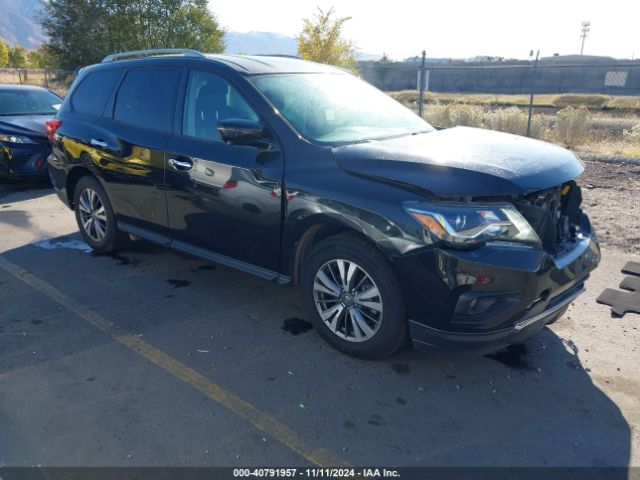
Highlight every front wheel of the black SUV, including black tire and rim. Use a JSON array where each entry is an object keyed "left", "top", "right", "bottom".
[{"left": 300, "top": 234, "right": 408, "bottom": 359}]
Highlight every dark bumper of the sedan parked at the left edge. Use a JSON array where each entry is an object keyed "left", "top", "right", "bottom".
[{"left": 0, "top": 143, "right": 51, "bottom": 179}]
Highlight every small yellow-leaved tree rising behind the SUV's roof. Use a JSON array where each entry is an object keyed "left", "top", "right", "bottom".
[{"left": 296, "top": 7, "right": 356, "bottom": 66}]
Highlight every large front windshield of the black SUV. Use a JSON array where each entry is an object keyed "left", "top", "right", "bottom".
[{"left": 253, "top": 73, "right": 433, "bottom": 143}]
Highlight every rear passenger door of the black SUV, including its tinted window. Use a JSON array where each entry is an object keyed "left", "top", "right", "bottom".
[{"left": 90, "top": 66, "right": 181, "bottom": 233}]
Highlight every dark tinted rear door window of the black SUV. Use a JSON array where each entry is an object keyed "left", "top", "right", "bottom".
[{"left": 113, "top": 68, "right": 179, "bottom": 131}]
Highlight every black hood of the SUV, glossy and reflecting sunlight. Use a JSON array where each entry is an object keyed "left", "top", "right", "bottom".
[{"left": 333, "top": 127, "right": 584, "bottom": 197}]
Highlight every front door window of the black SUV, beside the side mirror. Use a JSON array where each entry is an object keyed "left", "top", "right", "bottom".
[{"left": 182, "top": 71, "right": 258, "bottom": 142}]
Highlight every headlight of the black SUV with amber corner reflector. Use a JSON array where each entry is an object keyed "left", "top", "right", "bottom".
[{"left": 405, "top": 203, "right": 540, "bottom": 247}]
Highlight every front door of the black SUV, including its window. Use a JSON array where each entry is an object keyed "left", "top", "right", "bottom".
[{"left": 166, "top": 69, "right": 284, "bottom": 278}]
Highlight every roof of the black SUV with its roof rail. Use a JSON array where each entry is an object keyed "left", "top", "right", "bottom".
[{"left": 89, "top": 52, "right": 344, "bottom": 75}]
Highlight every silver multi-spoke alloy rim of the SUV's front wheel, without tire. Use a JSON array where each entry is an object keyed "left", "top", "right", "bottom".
[{"left": 313, "top": 259, "right": 382, "bottom": 342}]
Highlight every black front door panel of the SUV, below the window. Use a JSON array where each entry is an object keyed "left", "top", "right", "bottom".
[{"left": 166, "top": 136, "right": 283, "bottom": 271}]
